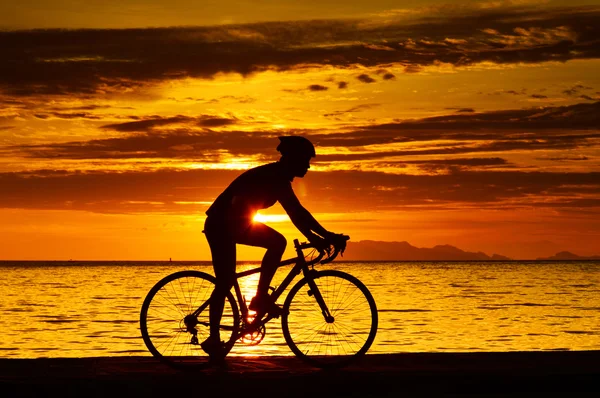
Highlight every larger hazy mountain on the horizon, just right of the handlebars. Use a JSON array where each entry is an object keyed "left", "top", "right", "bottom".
[{"left": 343, "top": 240, "right": 510, "bottom": 261}]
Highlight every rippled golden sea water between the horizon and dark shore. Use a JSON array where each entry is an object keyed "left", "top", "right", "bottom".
[{"left": 0, "top": 261, "right": 600, "bottom": 358}]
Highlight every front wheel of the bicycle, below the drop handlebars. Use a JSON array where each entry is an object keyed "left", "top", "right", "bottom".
[{"left": 281, "top": 270, "right": 378, "bottom": 368}]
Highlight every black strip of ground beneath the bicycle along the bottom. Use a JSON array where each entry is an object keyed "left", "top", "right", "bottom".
[{"left": 0, "top": 351, "right": 600, "bottom": 398}]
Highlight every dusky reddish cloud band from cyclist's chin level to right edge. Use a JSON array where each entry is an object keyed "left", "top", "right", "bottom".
[{"left": 310, "top": 171, "right": 600, "bottom": 213}]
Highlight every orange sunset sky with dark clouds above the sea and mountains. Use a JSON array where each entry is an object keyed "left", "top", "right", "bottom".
[{"left": 0, "top": 0, "right": 600, "bottom": 260}]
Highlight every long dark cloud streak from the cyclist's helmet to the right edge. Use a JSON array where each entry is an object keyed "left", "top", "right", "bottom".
[{"left": 310, "top": 102, "right": 600, "bottom": 162}]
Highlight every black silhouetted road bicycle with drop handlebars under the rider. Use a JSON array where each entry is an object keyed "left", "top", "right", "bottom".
[{"left": 140, "top": 236, "right": 378, "bottom": 368}]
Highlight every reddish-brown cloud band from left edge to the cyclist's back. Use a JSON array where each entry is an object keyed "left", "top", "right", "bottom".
[{"left": 0, "top": 170, "right": 238, "bottom": 212}]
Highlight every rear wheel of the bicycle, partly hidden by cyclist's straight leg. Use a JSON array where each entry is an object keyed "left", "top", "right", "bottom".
[{"left": 140, "top": 271, "right": 239, "bottom": 368}]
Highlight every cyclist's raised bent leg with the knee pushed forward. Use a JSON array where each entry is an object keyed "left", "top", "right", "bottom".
[{"left": 236, "top": 222, "right": 287, "bottom": 306}]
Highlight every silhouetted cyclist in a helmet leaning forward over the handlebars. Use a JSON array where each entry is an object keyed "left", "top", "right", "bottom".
[{"left": 201, "top": 136, "right": 340, "bottom": 359}]
